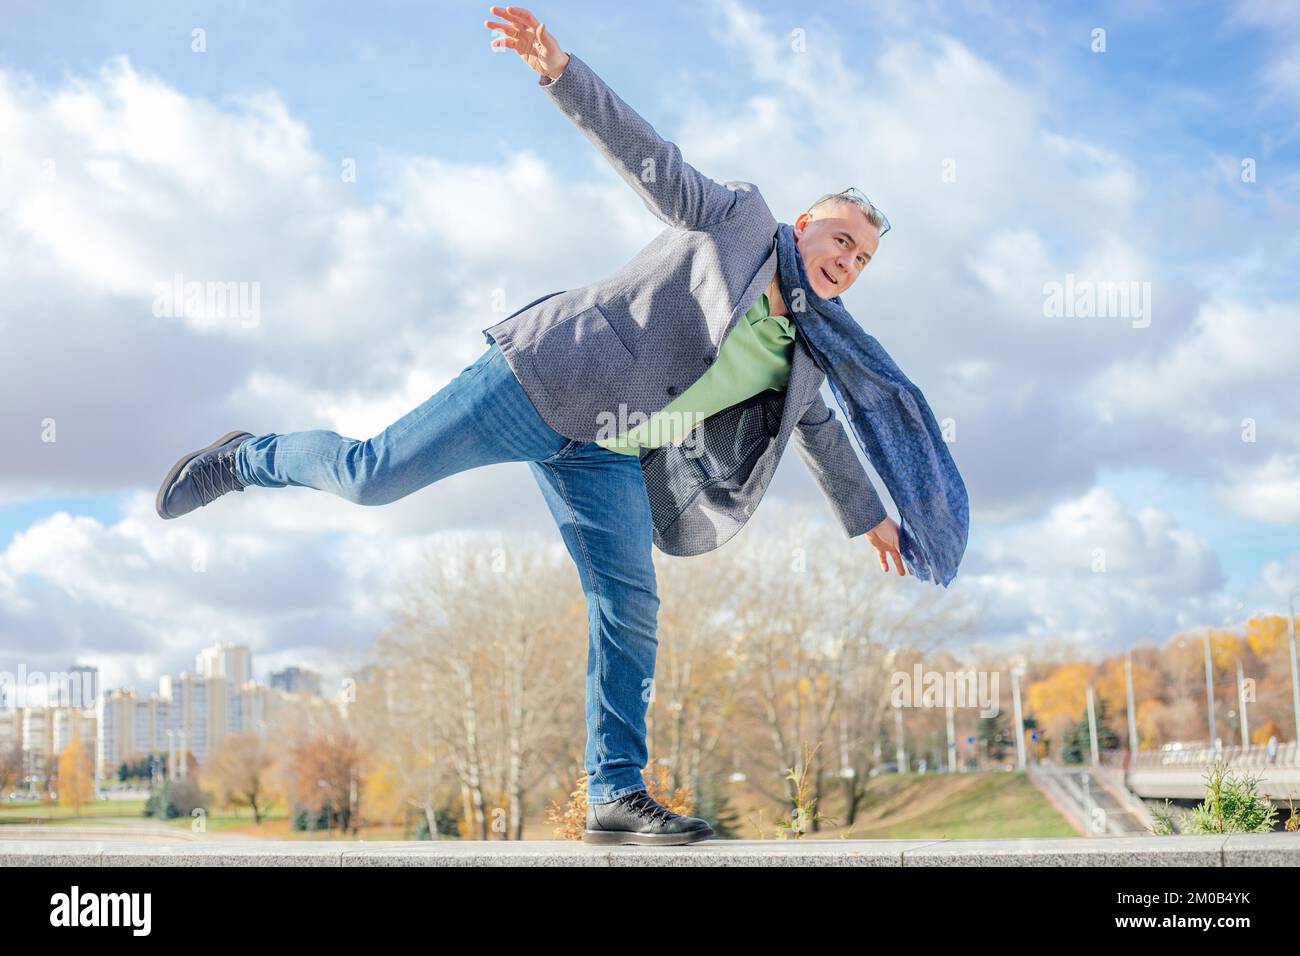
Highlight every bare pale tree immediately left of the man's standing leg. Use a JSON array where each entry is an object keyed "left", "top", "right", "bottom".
[{"left": 371, "top": 536, "right": 588, "bottom": 840}]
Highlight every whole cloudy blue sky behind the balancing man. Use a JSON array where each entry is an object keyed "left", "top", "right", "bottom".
[{"left": 0, "top": 0, "right": 1300, "bottom": 691}]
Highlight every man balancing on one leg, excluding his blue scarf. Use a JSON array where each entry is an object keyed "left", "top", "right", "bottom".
[{"left": 157, "top": 7, "right": 906, "bottom": 844}]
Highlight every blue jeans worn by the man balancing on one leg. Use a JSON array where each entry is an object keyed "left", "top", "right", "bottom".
[{"left": 235, "top": 342, "right": 659, "bottom": 804}]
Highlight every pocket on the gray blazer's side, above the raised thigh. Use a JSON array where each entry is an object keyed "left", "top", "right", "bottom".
[{"left": 533, "top": 306, "right": 633, "bottom": 405}]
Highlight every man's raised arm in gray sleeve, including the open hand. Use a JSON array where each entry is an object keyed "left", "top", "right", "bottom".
[{"left": 484, "top": 7, "right": 749, "bottom": 229}]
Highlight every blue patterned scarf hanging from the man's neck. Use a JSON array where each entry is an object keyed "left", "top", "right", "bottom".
[{"left": 776, "top": 222, "right": 970, "bottom": 588}]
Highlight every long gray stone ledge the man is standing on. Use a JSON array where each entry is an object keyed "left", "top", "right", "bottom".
[{"left": 0, "top": 832, "right": 1300, "bottom": 868}]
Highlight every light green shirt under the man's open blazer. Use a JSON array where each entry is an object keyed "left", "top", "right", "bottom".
[{"left": 595, "top": 293, "right": 794, "bottom": 455}]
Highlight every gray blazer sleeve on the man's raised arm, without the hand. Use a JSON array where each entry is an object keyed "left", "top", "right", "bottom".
[{"left": 537, "top": 53, "right": 753, "bottom": 229}]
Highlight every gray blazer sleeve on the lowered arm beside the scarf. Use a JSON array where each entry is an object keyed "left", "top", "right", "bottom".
[{"left": 792, "top": 393, "right": 889, "bottom": 537}]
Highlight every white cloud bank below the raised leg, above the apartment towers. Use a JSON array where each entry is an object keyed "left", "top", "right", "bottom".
[{"left": 0, "top": 489, "right": 554, "bottom": 688}]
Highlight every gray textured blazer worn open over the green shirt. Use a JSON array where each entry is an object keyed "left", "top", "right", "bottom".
[{"left": 482, "top": 53, "right": 887, "bottom": 555}]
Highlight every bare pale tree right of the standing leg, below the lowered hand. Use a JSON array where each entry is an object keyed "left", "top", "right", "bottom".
[{"left": 728, "top": 506, "right": 965, "bottom": 830}]
